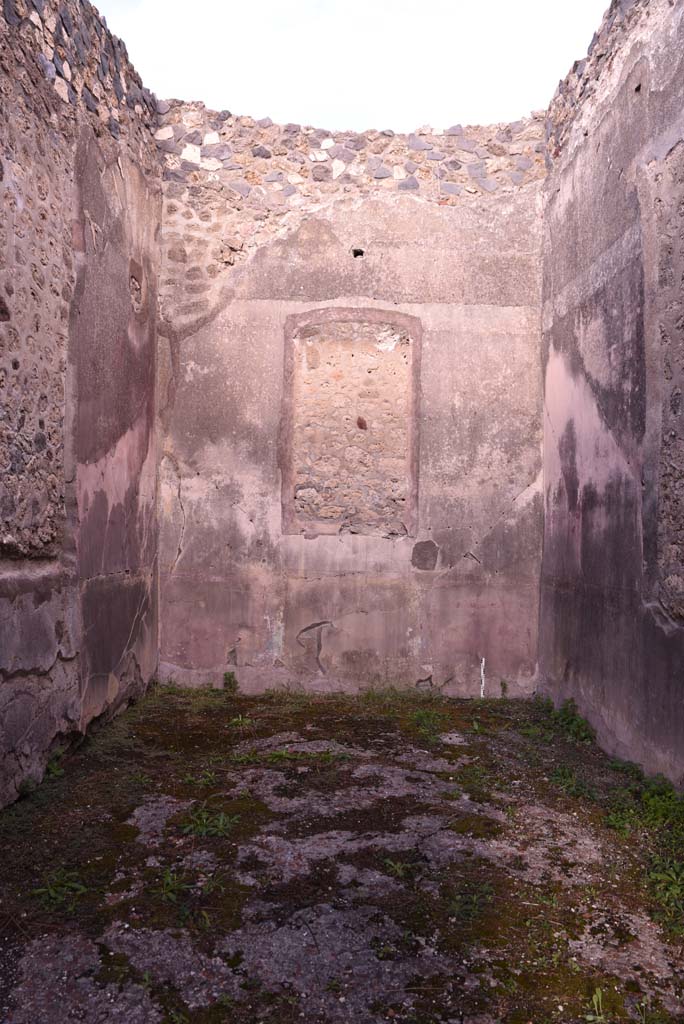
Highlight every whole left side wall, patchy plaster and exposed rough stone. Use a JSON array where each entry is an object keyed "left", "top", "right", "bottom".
[{"left": 0, "top": 0, "right": 160, "bottom": 805}]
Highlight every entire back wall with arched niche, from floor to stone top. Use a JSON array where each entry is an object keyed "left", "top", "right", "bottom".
[{"left": 158, "top": 105, "right": 544, "bottom": 695}]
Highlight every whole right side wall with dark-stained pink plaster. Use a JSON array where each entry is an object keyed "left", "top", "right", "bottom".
[{"left": 540, "top": 0, "right": 684, "bottom": 782}]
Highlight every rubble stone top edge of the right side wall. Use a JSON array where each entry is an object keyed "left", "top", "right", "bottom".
[{"left": 547, "top": 0, "right": 651, "bottom": 161}]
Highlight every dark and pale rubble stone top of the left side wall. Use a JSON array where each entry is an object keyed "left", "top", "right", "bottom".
[{"left": 0, "top": 0, "right": 157, "bottom": 170}]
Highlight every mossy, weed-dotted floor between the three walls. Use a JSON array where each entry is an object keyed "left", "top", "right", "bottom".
[{"left": 0, "top": 688, "right": 684, "bottom": 1024}]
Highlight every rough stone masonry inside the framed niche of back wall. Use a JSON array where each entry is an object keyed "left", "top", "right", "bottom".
[{"left": 291, "top": 322, "right": 412, "bottom": 537}]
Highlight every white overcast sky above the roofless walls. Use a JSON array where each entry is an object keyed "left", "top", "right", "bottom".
[{"left": 95, "top": 0, "right": 608, "bottom": 132}]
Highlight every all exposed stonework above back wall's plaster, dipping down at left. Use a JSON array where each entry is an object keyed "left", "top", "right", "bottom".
[{"left": 156, "top": 100, "right": 546, "bottom": 332}]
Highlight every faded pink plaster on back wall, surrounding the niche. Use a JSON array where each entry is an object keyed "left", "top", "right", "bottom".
[{"left": 160, "top": 169, "right": 542, "bottom": 694}]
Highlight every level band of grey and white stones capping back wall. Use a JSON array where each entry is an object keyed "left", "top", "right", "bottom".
[{"left": 156, "top": 100, "right": 545, "bottom": 210}]
